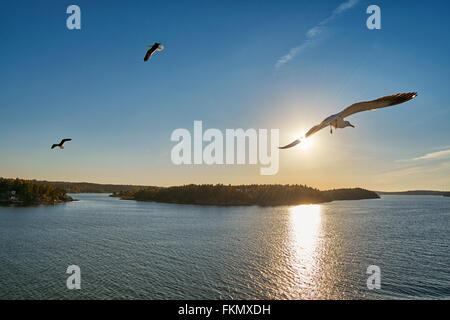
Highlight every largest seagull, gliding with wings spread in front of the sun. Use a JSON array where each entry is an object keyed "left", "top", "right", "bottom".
[{"left": 279, "top": 92, "right": 417, "bottom": 149}]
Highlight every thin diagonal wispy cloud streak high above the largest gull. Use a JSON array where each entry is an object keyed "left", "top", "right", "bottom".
[{"left": 275, "top": 0, "right": 359, "bottom": 68}]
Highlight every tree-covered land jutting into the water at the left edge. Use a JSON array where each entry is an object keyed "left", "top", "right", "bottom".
[{"left": 0, "top": 178, "right": 73, "bottom": 206}]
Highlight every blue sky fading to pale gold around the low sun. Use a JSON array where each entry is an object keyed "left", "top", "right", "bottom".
[{"left": 0, "top": 0, "right": 450, "bottom": 191}]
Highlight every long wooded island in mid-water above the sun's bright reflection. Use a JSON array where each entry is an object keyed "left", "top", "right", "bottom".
[{"left": 111, "top": 184, "right": 380, "bottom": 206}]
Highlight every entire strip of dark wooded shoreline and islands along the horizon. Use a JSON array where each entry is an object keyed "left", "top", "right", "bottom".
[{"left": 0, "top": 178, "right": 450, "bottom": 207}]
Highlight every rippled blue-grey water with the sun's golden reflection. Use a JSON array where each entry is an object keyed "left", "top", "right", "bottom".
[{"left": 0, "top": 194, "right": 450, "bottom": 299}]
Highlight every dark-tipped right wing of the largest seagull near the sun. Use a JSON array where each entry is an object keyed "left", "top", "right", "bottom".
[{"left": 339, "top": 92, "right": 417, "bottom": 119}]
